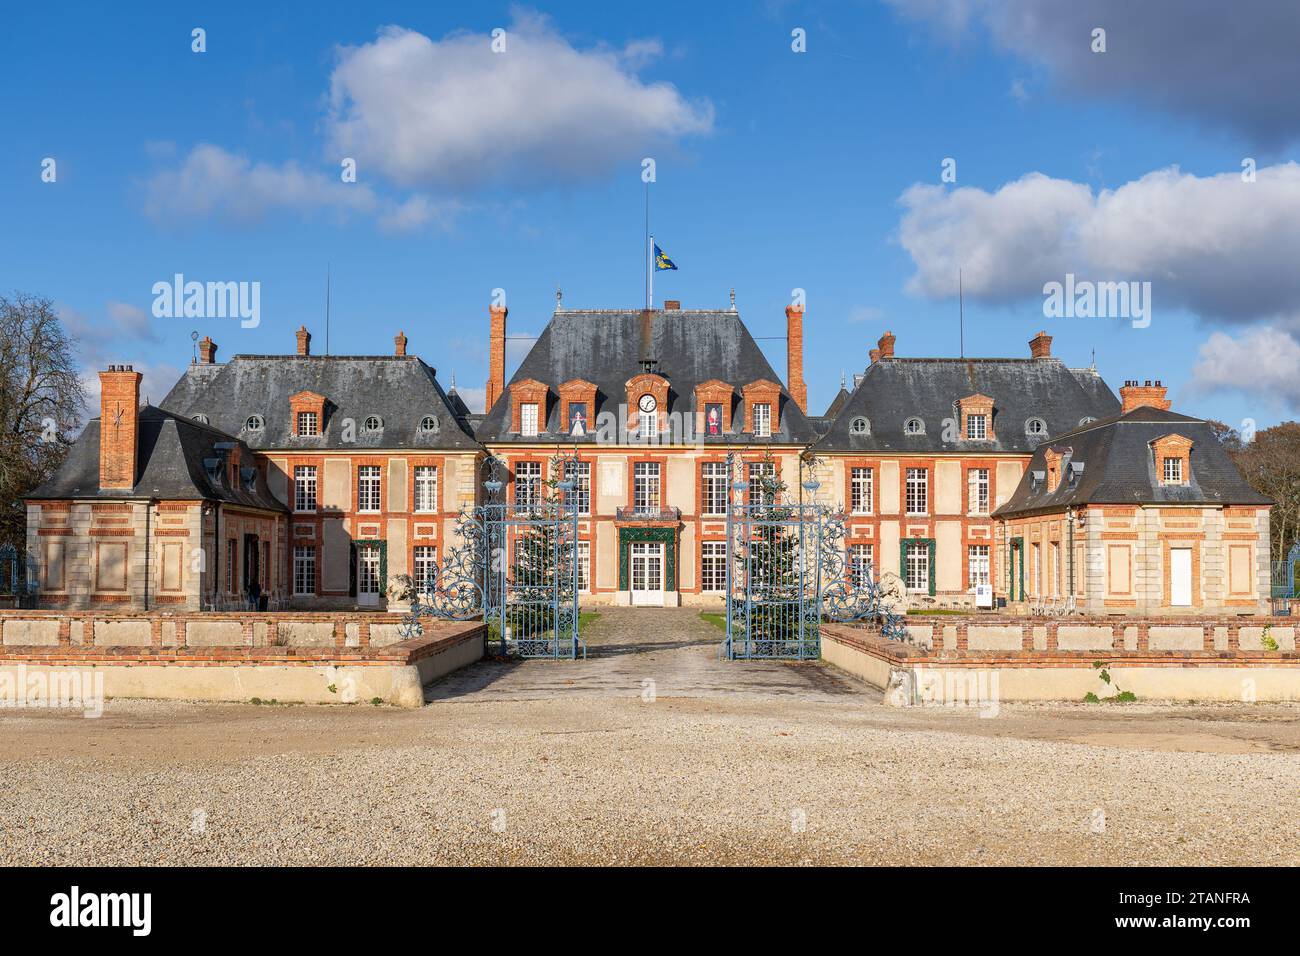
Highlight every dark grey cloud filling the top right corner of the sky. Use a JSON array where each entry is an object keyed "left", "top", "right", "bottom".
[{"left": 888, "top": 0, "right": 1300, "bottom": 146}]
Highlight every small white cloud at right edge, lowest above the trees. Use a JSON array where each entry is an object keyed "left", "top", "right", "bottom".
[{"left": 1190, "top": 325, "right": 1300, "bottom": 408}]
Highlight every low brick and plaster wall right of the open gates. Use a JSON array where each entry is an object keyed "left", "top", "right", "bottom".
[{"left": 822, "top": 617, "right": 1300, "bottom": 702}]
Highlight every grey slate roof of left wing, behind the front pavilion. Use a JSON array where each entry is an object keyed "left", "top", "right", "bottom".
[{"left": 163, "top": 355, "right": 478, "bottom": 450}]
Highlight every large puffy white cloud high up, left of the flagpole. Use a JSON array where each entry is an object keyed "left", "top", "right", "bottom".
[{"left": 328, "top": 12, "right": 712, "bottom": 187}]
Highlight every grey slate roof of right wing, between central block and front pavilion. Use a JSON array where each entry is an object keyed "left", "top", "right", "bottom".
[{"left": 813, "top": 356, "right": 1121, "bottom": 454}]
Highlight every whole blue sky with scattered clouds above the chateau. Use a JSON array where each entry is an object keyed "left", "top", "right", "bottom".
[{"left": 0, "top": 0, "right": 1300, "bottom": 427}]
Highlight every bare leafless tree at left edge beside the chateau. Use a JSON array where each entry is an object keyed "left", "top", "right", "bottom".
[{"left": 0, "top": 293, "right": 86, "bottom": 550}]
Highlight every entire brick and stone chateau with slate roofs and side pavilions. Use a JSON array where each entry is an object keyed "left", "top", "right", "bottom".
[{"left": 27, "top": 297, "right": 1269, "bottom": 614}]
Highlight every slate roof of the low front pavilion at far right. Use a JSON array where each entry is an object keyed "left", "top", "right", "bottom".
[{"left": 993, "top": 407, "right": 1271, "bottom": 518}]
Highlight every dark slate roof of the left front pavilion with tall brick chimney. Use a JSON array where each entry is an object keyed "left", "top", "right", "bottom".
[{"left": 27, "top": 405, "right": 286, "bottom": 511}]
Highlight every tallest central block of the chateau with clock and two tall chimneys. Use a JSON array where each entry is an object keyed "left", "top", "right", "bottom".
[{"left": 477, "top": 300, "right": 816, "bottom": 605}]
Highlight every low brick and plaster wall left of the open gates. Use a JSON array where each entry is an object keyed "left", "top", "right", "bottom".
[{"left": 0, "top": 611, "right": 488, "bottom": 706}]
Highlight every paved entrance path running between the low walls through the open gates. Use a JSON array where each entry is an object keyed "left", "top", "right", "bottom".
[{"left": 425, "top": 607, "right": 879, "bottom": 701}]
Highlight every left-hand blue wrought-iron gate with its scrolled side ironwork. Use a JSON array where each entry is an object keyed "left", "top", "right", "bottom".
[{"left": 400, "top": 458, "right": 586, "bottom": 659}]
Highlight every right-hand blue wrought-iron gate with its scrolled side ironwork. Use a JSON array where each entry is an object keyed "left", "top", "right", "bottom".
[{"left": 723, "top": 455, "right": 909, "bottom": 661}]
